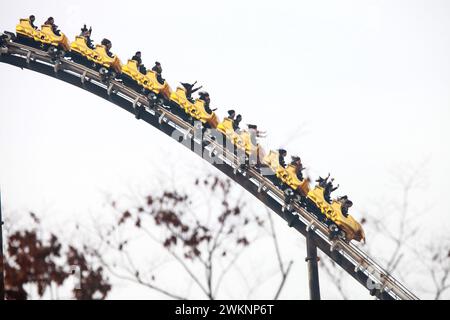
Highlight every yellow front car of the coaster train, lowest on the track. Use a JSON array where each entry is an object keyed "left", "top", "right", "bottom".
[{"left": 307, "top": 186, "right": 366, "bottom": 241}]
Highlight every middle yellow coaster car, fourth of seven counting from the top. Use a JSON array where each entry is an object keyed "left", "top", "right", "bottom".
[{"left": 170, "top": 87, "right": 219, "bottom": 128}]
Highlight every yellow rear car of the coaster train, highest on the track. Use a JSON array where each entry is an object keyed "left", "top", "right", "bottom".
[{"left": 16, "top": 19, "right": 70, "bottom": 51}]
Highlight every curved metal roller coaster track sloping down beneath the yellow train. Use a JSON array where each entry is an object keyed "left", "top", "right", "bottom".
[{"left": 0, "top": 37, "right": 418, "bottom": 300}]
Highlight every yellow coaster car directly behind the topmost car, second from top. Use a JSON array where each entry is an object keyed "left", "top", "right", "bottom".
[{"left": 70, "top": 36, "right": 122, "bottom": 73}]
